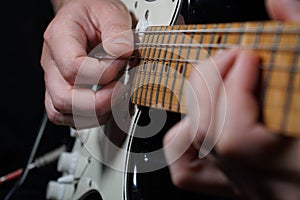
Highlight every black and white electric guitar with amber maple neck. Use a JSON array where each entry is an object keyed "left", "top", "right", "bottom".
[{"left": 48, "top": 0, "right": 300, "bottom": 200}]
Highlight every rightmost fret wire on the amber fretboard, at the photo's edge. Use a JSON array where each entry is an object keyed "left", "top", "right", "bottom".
[{"left": 281, "top": 32, "right": 300, "bottom": 133}]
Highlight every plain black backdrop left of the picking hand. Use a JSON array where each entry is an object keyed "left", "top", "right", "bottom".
[{"left": 0, "top": 0, "right": 69, "bottom": 200}]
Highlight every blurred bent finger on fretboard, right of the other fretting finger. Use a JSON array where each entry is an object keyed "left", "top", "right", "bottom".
[{"left": 217, "top": 51, "right": 276, "bottom": 159}]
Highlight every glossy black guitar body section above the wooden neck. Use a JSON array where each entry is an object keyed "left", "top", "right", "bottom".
[{"left": 181, "top": 0, "right": 269, "bottom": 24}]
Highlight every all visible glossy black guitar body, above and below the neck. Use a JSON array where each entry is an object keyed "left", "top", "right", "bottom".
[{"left": 124, "top": 0, "right": 268, "bottom": 200}]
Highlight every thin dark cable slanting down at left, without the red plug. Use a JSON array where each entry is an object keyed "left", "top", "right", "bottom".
[{"left": 4, "top": 112, "right": 48, "bottom": 200}]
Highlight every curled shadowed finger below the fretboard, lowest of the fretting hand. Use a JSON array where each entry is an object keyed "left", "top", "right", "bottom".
[{"left": 164, "top": 117, "right": 233, "bottom": 195}]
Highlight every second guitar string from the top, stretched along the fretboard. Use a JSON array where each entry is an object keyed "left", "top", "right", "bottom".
[{"left": 136, "top": 43, "right": 300, "bottom": 52}]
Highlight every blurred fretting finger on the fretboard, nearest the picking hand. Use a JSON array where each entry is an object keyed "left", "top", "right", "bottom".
[{"left": 186, "top": 49, "right": 238, "bottom": 156}]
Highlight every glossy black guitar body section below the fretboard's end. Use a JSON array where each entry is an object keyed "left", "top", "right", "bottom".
[{"left": 127, "top": 107, "right": 225, "bottom": 200}]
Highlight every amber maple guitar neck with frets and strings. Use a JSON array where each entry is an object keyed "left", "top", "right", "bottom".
[{"left": 132, "top": 21, "right": 300, "bottom": 136}]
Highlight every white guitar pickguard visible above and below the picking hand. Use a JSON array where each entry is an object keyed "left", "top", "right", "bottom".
[{"left": 44, "top": 0, "right": 182, "bottom": 200}]
